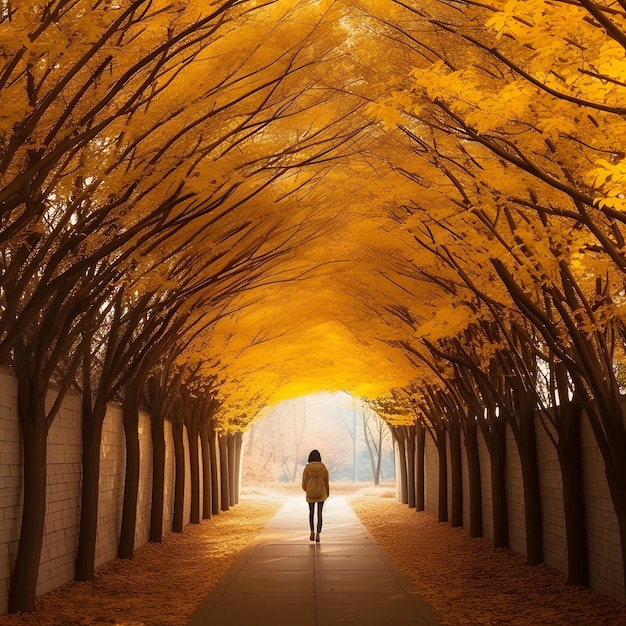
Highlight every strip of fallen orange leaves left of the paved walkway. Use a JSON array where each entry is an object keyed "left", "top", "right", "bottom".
[{"left": 0, "top": 498, "right": 282, "bottom": 626}]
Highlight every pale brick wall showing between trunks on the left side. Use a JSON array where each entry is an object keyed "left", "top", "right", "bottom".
[{"left": 0, "top": 368, "right": 197, "bottom": 615}]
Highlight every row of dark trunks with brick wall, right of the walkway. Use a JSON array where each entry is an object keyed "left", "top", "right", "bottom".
[{"left": 392, "top": 404, "right": 626, "bottom": 603}]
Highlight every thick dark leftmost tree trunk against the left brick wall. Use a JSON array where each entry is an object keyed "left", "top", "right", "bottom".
[{"left": 8, "top": 365, "right": 47, "bottom": 613}]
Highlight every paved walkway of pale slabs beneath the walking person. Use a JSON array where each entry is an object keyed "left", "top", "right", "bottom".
[{"left": 188, "top": 496, "right": 439, "bottom": 626}]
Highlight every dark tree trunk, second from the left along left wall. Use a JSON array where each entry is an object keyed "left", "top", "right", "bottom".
[{"left": 75, "top": 399, "right": 106, "bottom": 581}]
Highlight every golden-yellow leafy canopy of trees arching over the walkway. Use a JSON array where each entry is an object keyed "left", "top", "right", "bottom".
[{"left": 0, "top": 0, "right": 626, "bottom": 616}]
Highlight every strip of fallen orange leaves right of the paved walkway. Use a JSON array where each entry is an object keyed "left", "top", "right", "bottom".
[{"left": 350, "top": 493, "right": 626, "bottom": 626}]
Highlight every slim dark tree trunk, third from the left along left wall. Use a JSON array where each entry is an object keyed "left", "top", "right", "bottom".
[{"left": 117, "top": 385, "right": 141, "bottom": 559}]
